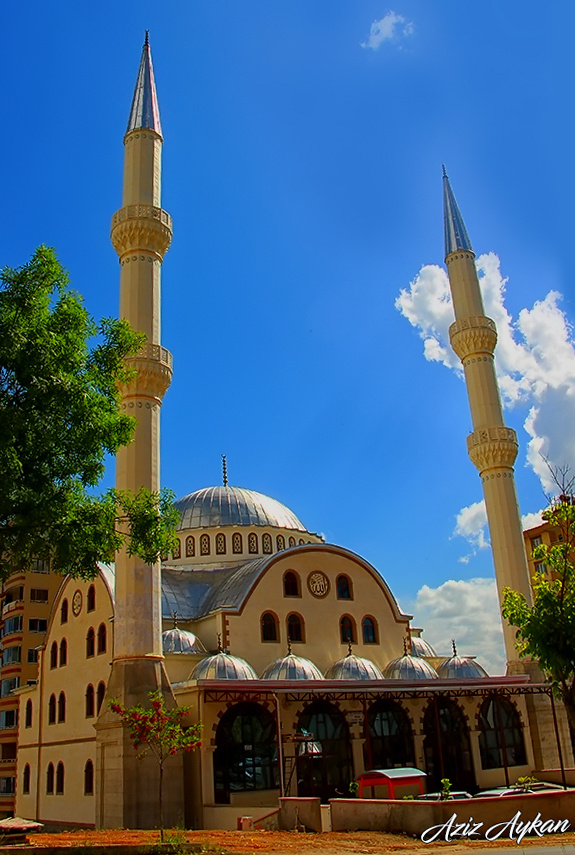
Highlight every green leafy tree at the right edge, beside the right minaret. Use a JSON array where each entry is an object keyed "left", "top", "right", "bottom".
[{"left": 502, "top": 467, "right": 575, "bottom": 733}]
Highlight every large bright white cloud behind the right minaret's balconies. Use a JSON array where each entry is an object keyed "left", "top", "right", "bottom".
[{"left": 395, "top": 252, "right": 575, "bottom": 504}]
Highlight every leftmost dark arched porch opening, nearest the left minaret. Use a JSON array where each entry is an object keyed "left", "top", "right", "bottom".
[{"left": 214, "top": 703, "right": 279, "bottom": 804}]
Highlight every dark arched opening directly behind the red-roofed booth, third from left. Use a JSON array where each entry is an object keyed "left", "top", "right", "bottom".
[{"left": 364, "top": 698, "right": 415, "bottom": 769}]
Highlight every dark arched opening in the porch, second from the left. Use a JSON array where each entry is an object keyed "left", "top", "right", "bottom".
[{"left": 296, "top": 701, "right": 353, "bottom": 803}]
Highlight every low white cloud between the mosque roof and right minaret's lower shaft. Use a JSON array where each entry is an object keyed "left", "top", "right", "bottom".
[{"left": 413, "top": 579, "right": 506, "bottom": 676}]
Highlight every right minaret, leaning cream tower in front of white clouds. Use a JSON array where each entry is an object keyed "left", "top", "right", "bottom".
[{"left": 443, "top": 168, "right": 532, "bottom": 670}]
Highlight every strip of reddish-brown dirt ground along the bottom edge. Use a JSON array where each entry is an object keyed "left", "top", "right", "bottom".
[{"left": 25, "top": 829, "right": 575, "bottom": 855}]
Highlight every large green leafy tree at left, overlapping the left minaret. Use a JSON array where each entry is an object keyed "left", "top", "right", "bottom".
[{"left": 0, "top": 247, "right": 177, "bottom": 579}]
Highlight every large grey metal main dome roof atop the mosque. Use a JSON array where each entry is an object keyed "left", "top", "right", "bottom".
[{"left": 175, "top": 487, "right": 307, "bottom": 531}]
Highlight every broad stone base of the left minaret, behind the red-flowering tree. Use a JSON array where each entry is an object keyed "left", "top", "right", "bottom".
[{"left": 95, "top": 657, "right": 184, "bottom": 828}]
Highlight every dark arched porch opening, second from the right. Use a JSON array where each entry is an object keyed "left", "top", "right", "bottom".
[{"left": 423, "top": 697, "right": 476, "bottom": 792}]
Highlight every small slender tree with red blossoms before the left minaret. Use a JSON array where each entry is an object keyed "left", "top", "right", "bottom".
[{"left": 110, "top": 692, "right": 202, "bottom": 842}]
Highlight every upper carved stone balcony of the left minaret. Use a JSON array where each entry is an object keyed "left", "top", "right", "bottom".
[{"left": 110, "top": 205, "right": 172, "bottom": 261}]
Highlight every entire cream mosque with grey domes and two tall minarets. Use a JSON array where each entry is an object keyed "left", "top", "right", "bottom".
[{"left": 9, "top": 37, "right": 572, "bottom": 828}]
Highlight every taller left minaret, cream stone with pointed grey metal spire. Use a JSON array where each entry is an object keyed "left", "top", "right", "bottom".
[{"left": 96, "top": 33, "right": 181, "bottom": 828}]
